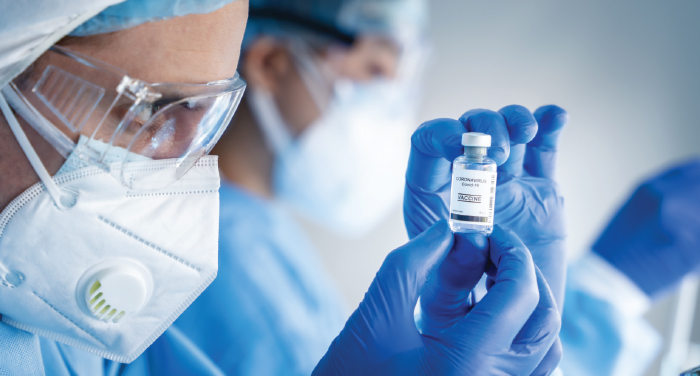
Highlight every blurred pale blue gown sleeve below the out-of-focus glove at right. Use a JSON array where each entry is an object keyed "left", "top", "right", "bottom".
[{"left": 559, "top": 252, "right": 662, "bottom": 376}]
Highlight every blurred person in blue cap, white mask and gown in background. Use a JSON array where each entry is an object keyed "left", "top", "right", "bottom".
[{"left": 175, "top": 0, "right": 426, "bottom": 375}]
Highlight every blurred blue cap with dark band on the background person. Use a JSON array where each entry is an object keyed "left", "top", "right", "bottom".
[{"left": 243, "top": 0, "right": 427, "bottom": 49}]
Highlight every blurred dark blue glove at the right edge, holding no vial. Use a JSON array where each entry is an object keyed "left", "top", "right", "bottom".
[{"left": 593, "top": 160, "right": 700, "bottom": 299}]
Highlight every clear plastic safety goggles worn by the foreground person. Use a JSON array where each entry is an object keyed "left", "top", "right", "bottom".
[{"left": 5, "top": 46, "right": 246, "bottom": 190}]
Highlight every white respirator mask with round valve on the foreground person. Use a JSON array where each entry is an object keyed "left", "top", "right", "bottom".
[{"left": 0, "top": 89, "right": 219, "bottom": 363}]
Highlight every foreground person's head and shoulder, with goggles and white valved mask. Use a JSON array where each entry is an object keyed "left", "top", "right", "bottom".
[{"left": 0, "top": 1, "right": 247, "bottom": 375}]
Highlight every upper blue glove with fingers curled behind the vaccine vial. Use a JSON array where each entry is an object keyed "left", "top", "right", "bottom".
[{"left": 403, "top": 105, "right": 568, "bottom": 309}]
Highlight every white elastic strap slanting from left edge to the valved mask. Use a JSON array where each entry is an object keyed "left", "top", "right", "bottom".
[{"left": 0, "top": 93, "right": 75, "bottom": 210}]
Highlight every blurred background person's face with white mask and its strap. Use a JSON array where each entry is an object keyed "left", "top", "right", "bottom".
[{"left": 248, "top": 35, "right": 422, "bottom": 237}]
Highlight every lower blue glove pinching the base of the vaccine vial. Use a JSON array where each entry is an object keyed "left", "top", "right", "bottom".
[{"left": 314, "top": 221, "right": 560, "bottom": 375}]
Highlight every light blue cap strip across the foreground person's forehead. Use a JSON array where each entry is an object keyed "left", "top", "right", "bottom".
[{"left": 70, "top": 0, "right": 235, "bottom": 36}]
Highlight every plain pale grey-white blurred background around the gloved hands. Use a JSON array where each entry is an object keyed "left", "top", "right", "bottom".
[{"left": 306, "top": 0, "right": 700, "bottom": 375}]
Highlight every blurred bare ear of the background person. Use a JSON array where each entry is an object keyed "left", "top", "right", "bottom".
[{"left": 242, "top": 36, "right": 294, "bottom": 95}]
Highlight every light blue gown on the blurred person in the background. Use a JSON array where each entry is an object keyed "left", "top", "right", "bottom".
[{"left": 174, "top": 181, "right": 347, "bottom": 375}]
